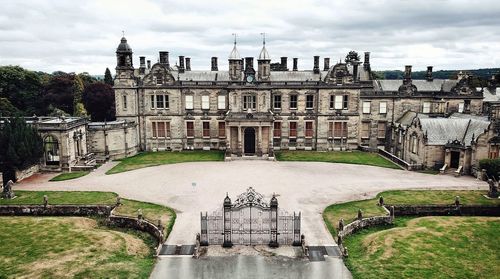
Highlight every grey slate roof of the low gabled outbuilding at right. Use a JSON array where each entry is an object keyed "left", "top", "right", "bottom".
[{"left": 419, "top": 117, "right": 490, "bottom": 146}]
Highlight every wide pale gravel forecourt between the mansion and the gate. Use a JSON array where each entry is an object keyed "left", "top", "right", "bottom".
[{"left": 16, "top": 161, "right": 487, "bottom": 245}]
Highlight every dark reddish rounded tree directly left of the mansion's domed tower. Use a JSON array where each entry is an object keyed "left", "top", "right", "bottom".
[{"left": 83, "top": 82, "right": 115, "bottom": 121}]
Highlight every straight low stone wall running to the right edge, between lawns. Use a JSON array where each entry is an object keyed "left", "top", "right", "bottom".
[{"left": 386, "top": 205, "right": 500, "bottom": 219}]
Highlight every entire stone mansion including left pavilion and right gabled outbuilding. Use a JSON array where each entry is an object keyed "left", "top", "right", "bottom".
[{"left": 4, "top": 38, "right": 500, "bottom": 178}]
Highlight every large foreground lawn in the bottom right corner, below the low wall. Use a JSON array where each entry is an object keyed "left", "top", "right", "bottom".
[{"left": 344, "top": 217, "right": 500, "bottom": 279}]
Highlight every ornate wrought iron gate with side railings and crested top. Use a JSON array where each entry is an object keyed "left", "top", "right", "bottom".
[{"left": 200, "top": 187, "right": 301, "bottom": 247}]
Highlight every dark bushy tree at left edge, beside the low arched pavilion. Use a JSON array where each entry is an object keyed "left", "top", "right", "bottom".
[{"left": 0, "top": 117, "right": 43, "bottom": 183}]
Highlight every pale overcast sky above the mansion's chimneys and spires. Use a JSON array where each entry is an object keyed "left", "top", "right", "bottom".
[{"left": 0, "top": 0, "right": 500, "bottom": 74}]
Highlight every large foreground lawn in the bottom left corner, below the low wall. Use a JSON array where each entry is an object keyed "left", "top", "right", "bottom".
[{"left": 0, "top": 217, "right": 156, "bottom": 278}]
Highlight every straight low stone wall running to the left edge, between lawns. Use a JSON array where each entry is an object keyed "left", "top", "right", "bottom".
[{"left": 0, "top": 205, "right": 114, "bottom": 217}]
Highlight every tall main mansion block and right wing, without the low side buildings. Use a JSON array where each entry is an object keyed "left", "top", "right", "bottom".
[{"left": 114, "top": 38, "right": 498, "bottom": 174}]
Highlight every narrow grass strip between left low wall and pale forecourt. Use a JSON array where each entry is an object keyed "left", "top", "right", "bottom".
[{"left": 0, "top": 191, "right": 176, "bottom": 236}]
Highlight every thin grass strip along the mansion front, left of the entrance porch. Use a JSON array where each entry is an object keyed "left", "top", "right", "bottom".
[{"left": 106, "top": 151, "right": 224, "bottom": 174}]
